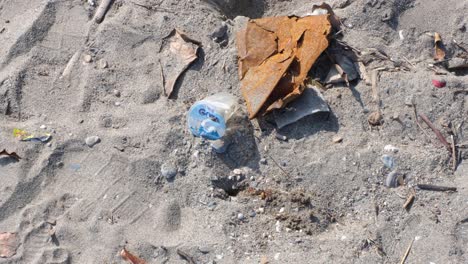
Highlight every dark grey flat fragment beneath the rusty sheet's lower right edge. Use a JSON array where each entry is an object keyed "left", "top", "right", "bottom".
[{"left": 273, "top": 85, "right": 330, "bottom": 128}]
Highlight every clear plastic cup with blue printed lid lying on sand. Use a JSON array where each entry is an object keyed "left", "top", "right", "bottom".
[{"left": 187, "top": 93, "right": 237, "bottom": 140}]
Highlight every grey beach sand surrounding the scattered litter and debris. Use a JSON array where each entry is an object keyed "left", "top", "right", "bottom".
[{"left": 0, "top": 0, "right": 468, "bottom": 264}]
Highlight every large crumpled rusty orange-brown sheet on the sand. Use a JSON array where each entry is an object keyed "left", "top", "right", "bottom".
[{"left": 237, "top": 15, "right": 331, "bottom": 118}]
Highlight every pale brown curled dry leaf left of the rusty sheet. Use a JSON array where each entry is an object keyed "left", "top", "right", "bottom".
[{"left": 161, "top": 29, "right": 200, "bottom": 97}]
